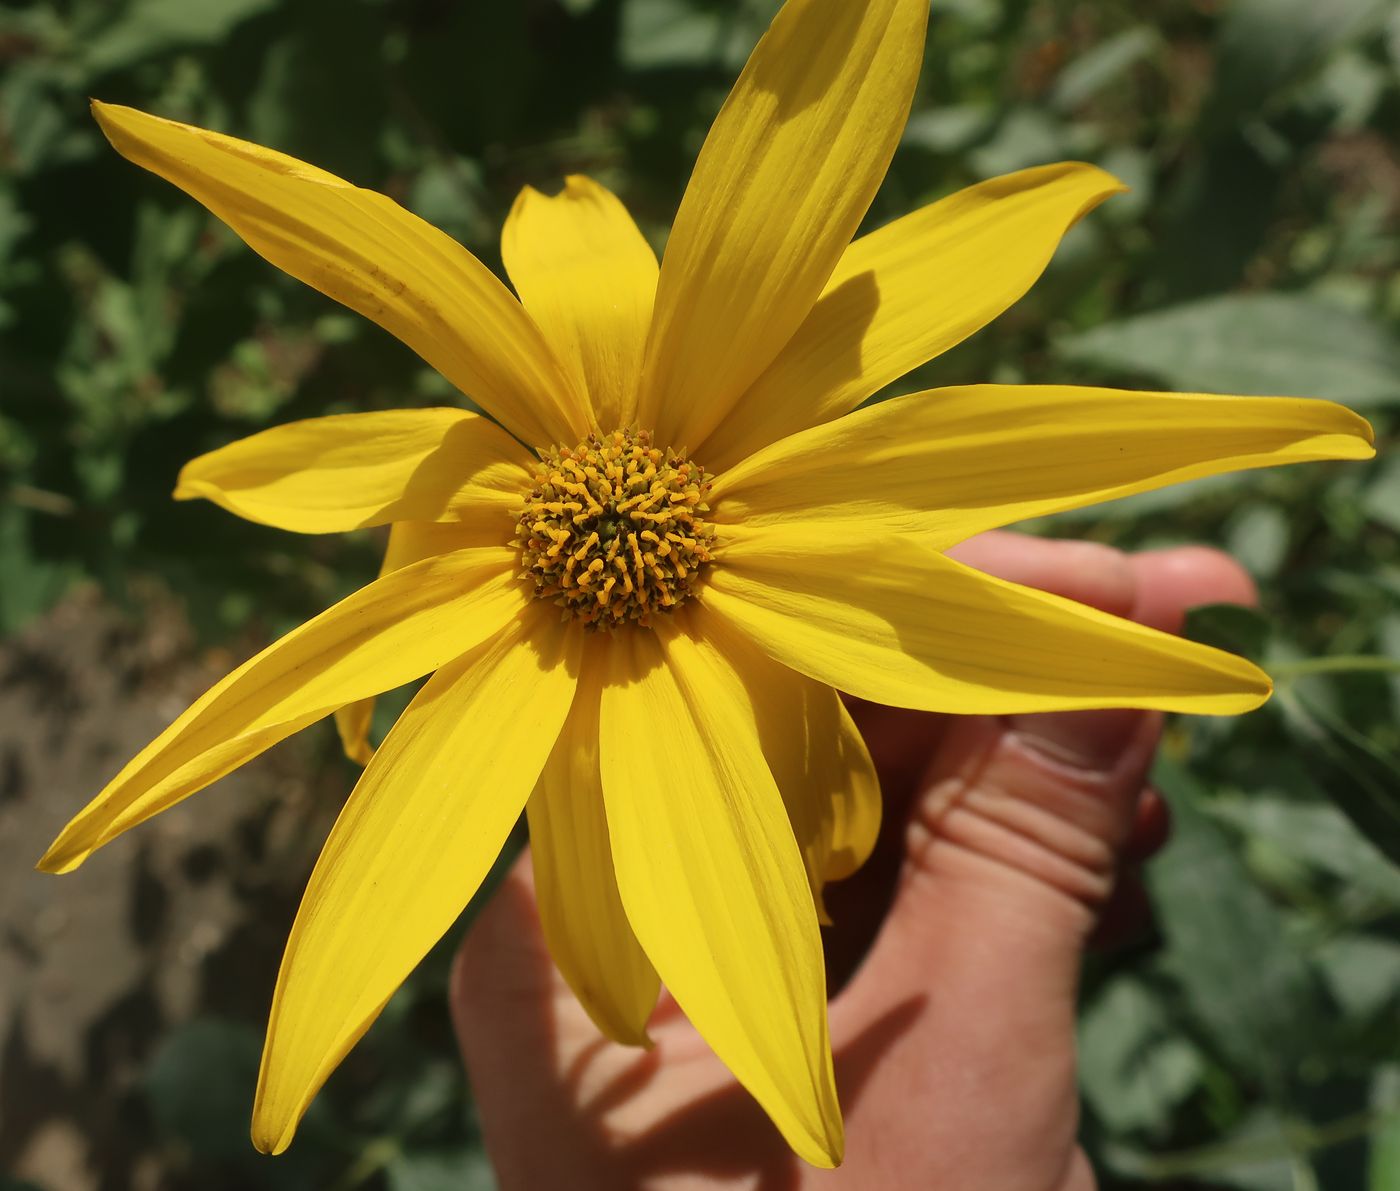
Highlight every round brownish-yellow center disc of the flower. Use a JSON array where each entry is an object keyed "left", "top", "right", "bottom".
[{"left": 515, "top": 430, "right": 714, "bottom": 628}]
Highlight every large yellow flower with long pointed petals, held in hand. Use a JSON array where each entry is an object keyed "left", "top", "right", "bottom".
[{"left": 41, "top": 0, "right": 1372, "bottom": 1166}]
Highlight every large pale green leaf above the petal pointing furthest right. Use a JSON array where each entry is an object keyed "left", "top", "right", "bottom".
[{"left": 1056, "top": 294, "right": 1400, "bottom": 406}]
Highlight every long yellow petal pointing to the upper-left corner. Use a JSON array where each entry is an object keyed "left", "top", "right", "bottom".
[{"left": 92, "top": 102, "right": 588, "bottom": 445}]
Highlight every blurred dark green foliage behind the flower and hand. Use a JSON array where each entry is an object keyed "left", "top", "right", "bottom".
[{"left": 0, "top": 0, "right": 1400, "bottom": 1191}]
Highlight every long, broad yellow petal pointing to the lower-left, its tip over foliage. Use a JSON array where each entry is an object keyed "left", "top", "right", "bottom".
[{"left": 252, "top": 603, "right": 582, "bottom": 1153}]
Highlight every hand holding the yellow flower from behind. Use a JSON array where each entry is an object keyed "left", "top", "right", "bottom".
[{"left": 451, "top": 533, "right": 1254, "bottom": 1191}]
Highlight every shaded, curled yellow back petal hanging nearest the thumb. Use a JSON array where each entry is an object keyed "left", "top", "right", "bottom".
[{"left": 704, "top": 617, "right": 881, "bottom": 924}]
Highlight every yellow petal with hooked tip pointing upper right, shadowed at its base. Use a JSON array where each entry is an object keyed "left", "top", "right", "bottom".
[{"left": 694, "top": 161, "right": 1124, "bottom": 472}]
